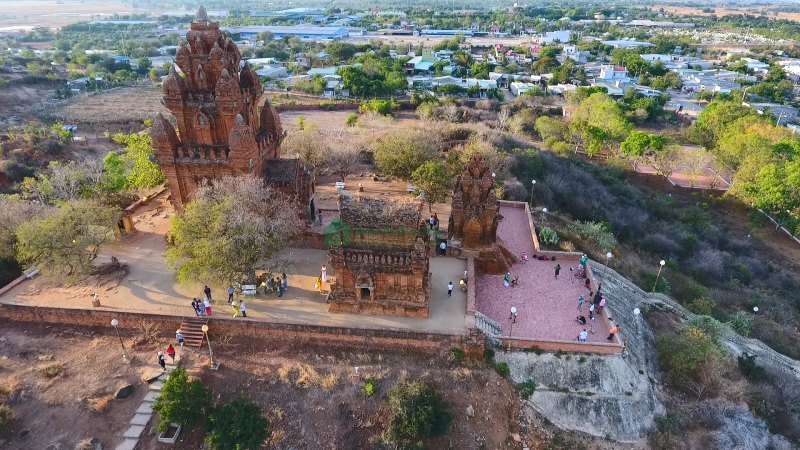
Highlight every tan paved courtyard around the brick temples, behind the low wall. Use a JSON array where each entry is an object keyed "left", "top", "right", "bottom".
[{"left": 0, "top": 198, "right": 466, "bottom": 334}]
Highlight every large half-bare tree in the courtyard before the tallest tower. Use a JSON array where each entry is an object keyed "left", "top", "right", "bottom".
[{"left": 167, "top": 177, "right": 302, "bottom": 285}]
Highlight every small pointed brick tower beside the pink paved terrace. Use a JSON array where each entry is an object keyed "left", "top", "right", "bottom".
[{"left": 448, "top": 156, "right": 503, "bottom": 246}]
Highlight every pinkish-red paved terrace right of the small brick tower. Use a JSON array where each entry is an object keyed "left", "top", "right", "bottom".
[{"left": 476, "top": 206, "right": 609, "bottom": 342}]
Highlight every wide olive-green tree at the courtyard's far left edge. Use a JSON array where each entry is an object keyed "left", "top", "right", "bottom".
[{"left": 16, "top": 200, "right": 121, "bottom": 276}]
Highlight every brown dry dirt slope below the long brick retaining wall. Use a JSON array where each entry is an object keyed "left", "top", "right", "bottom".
[{"left": 0, "top": 322, "right": 522, "bottom": 450}]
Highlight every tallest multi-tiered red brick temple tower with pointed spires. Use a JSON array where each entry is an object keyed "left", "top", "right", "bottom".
[{"left": 151, "top": 6, "right": 292, "bottom": 210}]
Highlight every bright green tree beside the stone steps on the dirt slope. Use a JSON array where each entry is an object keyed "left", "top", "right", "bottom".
[{"left": 153, "top": 367, "right": 211, "bottom": 432}]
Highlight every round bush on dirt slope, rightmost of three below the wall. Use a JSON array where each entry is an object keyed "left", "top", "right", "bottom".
[{"left": 383, "top": 381, "right": 453, "bottom": 448}]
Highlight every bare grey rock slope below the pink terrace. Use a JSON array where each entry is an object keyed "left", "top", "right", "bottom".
[{"left": 497, "top": 261, "right": 800, "bottom": 442}]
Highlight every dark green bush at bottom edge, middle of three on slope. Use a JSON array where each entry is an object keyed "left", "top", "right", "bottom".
[{"left": 205, "top": 394, "right": 269, "bottom": 450}]
